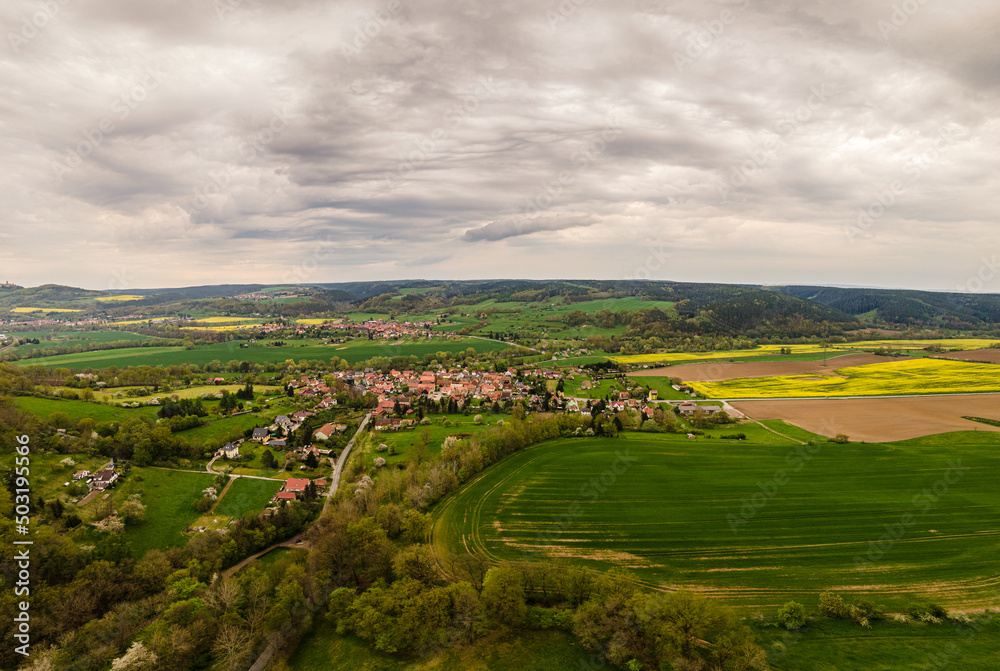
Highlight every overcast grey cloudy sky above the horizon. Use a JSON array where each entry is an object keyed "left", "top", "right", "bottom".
[{"left": 0, "top": 0, "right": 1000, "bottom": 292}]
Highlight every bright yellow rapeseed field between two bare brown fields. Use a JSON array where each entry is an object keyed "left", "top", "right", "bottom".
[{"left": 690, "top": 359, "right": 1000, "bottom": 399}]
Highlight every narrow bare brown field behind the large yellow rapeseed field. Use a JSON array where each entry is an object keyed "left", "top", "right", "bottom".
[{"left": 629, "top": 354, "right": 888, "bottom": 382}]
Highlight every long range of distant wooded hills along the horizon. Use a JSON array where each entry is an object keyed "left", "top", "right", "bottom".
[{"left": 7, "top": 279, "right": 1000, "bottom": 337}]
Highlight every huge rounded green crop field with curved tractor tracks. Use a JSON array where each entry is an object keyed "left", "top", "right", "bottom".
[{"left": 433, "top": 436, "right": 1000, "bottom": 610}]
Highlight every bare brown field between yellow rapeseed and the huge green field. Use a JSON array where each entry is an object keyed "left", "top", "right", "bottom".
[{"left": 732, "top": 396, "right": 1000, "bottom": 442}]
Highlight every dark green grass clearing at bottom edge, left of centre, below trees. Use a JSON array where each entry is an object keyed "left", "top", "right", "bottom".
[{"left": 289, "top": 618, "right": 617, "bottom": 671}]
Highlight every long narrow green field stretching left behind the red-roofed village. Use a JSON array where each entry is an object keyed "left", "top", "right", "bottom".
[{"left": 14, "top": 338, "right": 510, "bottom": 370}]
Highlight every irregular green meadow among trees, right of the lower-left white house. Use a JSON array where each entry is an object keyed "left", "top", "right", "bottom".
[{"left": 115, "top": 468, "right": 215, "bottom": 558}]
